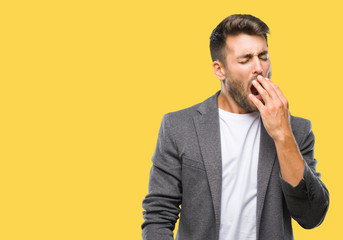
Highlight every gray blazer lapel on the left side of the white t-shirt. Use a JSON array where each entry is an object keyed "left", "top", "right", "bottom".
[{"left": 193, "top": 92, "right": 222, "bottom": 237}]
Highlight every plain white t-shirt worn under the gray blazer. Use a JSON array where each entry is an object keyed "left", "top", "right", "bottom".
[{"left": 219, "top": 108, "right": 261, "bottom": 240}]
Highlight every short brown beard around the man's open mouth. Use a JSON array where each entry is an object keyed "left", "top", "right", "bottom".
[{"left": 225, "top": 76, "right": 258, "bottom": 112}]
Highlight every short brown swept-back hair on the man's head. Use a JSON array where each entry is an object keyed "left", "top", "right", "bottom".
[{"left": 210, "top": 14, "right": 270, "bottom": 64}]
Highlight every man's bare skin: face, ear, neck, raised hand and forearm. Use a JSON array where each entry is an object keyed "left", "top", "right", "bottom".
[{"left": 212, "top": 34, "right": 304, "bottom": 186}]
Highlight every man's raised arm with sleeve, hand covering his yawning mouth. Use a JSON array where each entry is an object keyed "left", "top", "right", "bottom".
[{"left": 249, "top": 76, "right": 329, "bottom": 228}]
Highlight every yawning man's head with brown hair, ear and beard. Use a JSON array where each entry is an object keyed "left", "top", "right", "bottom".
[{"left": 210, "top": 15, "right": 271, "bottom": 112}]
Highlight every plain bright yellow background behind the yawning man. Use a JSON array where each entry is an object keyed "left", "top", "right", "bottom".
[{"left": 0, "top": 0, "right": 343, "bottom": 240}]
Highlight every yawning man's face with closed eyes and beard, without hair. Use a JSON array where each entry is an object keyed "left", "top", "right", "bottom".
[{"left": 224, "top": 34, "right": 271, "bottom": 112}]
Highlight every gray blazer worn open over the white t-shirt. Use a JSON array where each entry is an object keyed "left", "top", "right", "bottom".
[{"left": 142, "top": 91, "right": 329, "bottom": 240}]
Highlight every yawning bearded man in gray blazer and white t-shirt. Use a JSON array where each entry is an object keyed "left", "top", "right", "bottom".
[{"left": 142, "top": 15, "right": 329, "bottom": 240}]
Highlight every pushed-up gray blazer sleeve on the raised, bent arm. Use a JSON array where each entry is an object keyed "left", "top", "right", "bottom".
[{"left": 280, "top": 121, "right": 329, "bottom": 229}]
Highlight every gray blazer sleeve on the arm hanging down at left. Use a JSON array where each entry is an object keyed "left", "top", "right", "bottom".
[{"left": 142, "top": 114, "right": 182, "bottom": 240}]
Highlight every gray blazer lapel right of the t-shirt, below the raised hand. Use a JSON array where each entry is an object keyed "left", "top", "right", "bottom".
[{"left": 256, "top": 120, "right": 276, "bottom": 239}]
